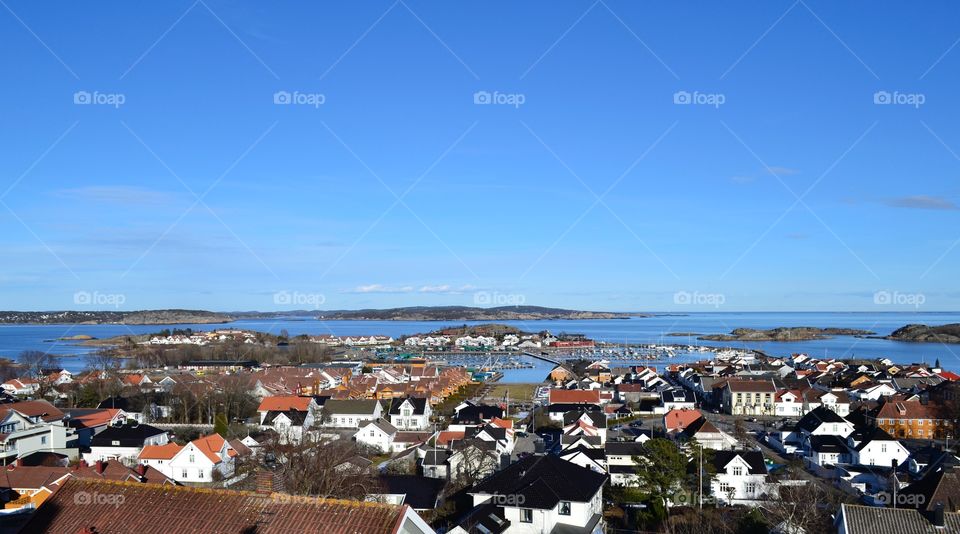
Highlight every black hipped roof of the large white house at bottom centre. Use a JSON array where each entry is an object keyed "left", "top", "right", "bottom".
[{"left": 469, "top": 454, "right": 607, "bottom": 509}]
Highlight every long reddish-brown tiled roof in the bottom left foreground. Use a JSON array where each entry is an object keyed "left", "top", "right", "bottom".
[{"left": 21, "top": 480, "right": 414, "bottom": 534}]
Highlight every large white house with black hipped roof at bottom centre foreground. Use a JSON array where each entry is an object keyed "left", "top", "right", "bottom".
[{"left": 460, "top": 454, "right": 607, "bottom": 534}]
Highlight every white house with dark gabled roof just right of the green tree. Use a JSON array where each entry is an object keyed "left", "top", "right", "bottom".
[{"left": 710, "top": 451, "right": 767, "bottom": 505}]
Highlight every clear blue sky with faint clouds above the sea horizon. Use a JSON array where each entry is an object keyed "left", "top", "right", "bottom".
[{"left": 0, "top": 0, "right": 960, "bottom": 311}]
